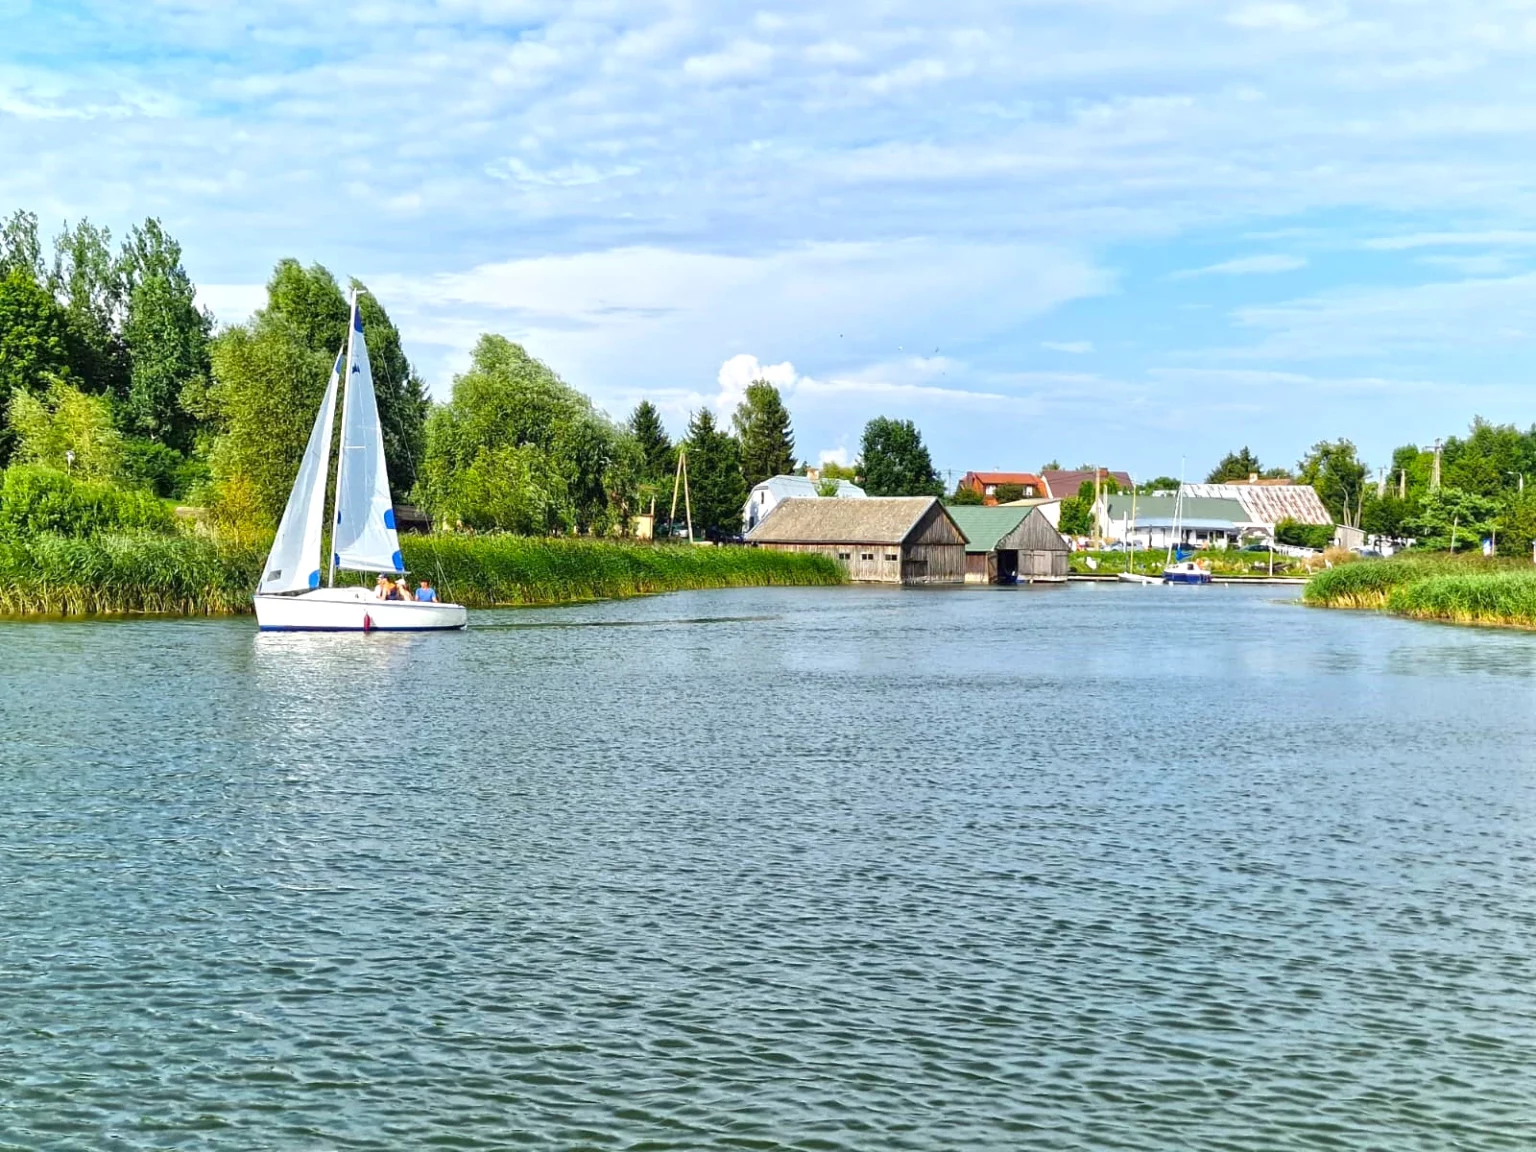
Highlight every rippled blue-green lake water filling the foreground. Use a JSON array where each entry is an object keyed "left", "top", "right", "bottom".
[{"left": 0, "top": 585, "right": 1536, "bottom": 1152}]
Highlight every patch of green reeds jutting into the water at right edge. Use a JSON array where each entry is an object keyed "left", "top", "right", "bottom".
[{"left": 1301, "top": 556, "right": 1536, "bottom": 630}]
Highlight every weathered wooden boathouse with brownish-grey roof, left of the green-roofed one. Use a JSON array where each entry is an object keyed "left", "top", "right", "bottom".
[{"left": 746, "top": 496, "right": 965, "bottom": 584}]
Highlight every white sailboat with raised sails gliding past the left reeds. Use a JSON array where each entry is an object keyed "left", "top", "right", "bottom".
[{"left": 253, "top": 290, "right": 468, "bottom": 631}]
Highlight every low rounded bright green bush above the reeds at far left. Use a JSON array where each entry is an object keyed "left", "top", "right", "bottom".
[{"left": 0, "top": 465, "right": 175, "bottom": 541}]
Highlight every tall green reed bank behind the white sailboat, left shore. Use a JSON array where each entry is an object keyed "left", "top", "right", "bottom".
[{"left": 0, "top": 535, "right": 843, "bottom": 616}]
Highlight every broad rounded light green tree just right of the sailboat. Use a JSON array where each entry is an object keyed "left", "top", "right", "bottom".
[{"left": 415, "top": 336, "right": 633, "bottom": 533}]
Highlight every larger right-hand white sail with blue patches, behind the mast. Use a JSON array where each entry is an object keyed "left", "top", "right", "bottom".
[{"left": 332, "top": 295, "right": 406, "bottom": 571}]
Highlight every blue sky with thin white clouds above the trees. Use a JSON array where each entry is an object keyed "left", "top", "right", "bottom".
[{"left": 0, "top": 0, "right": 1536, "bottom": 476}]
